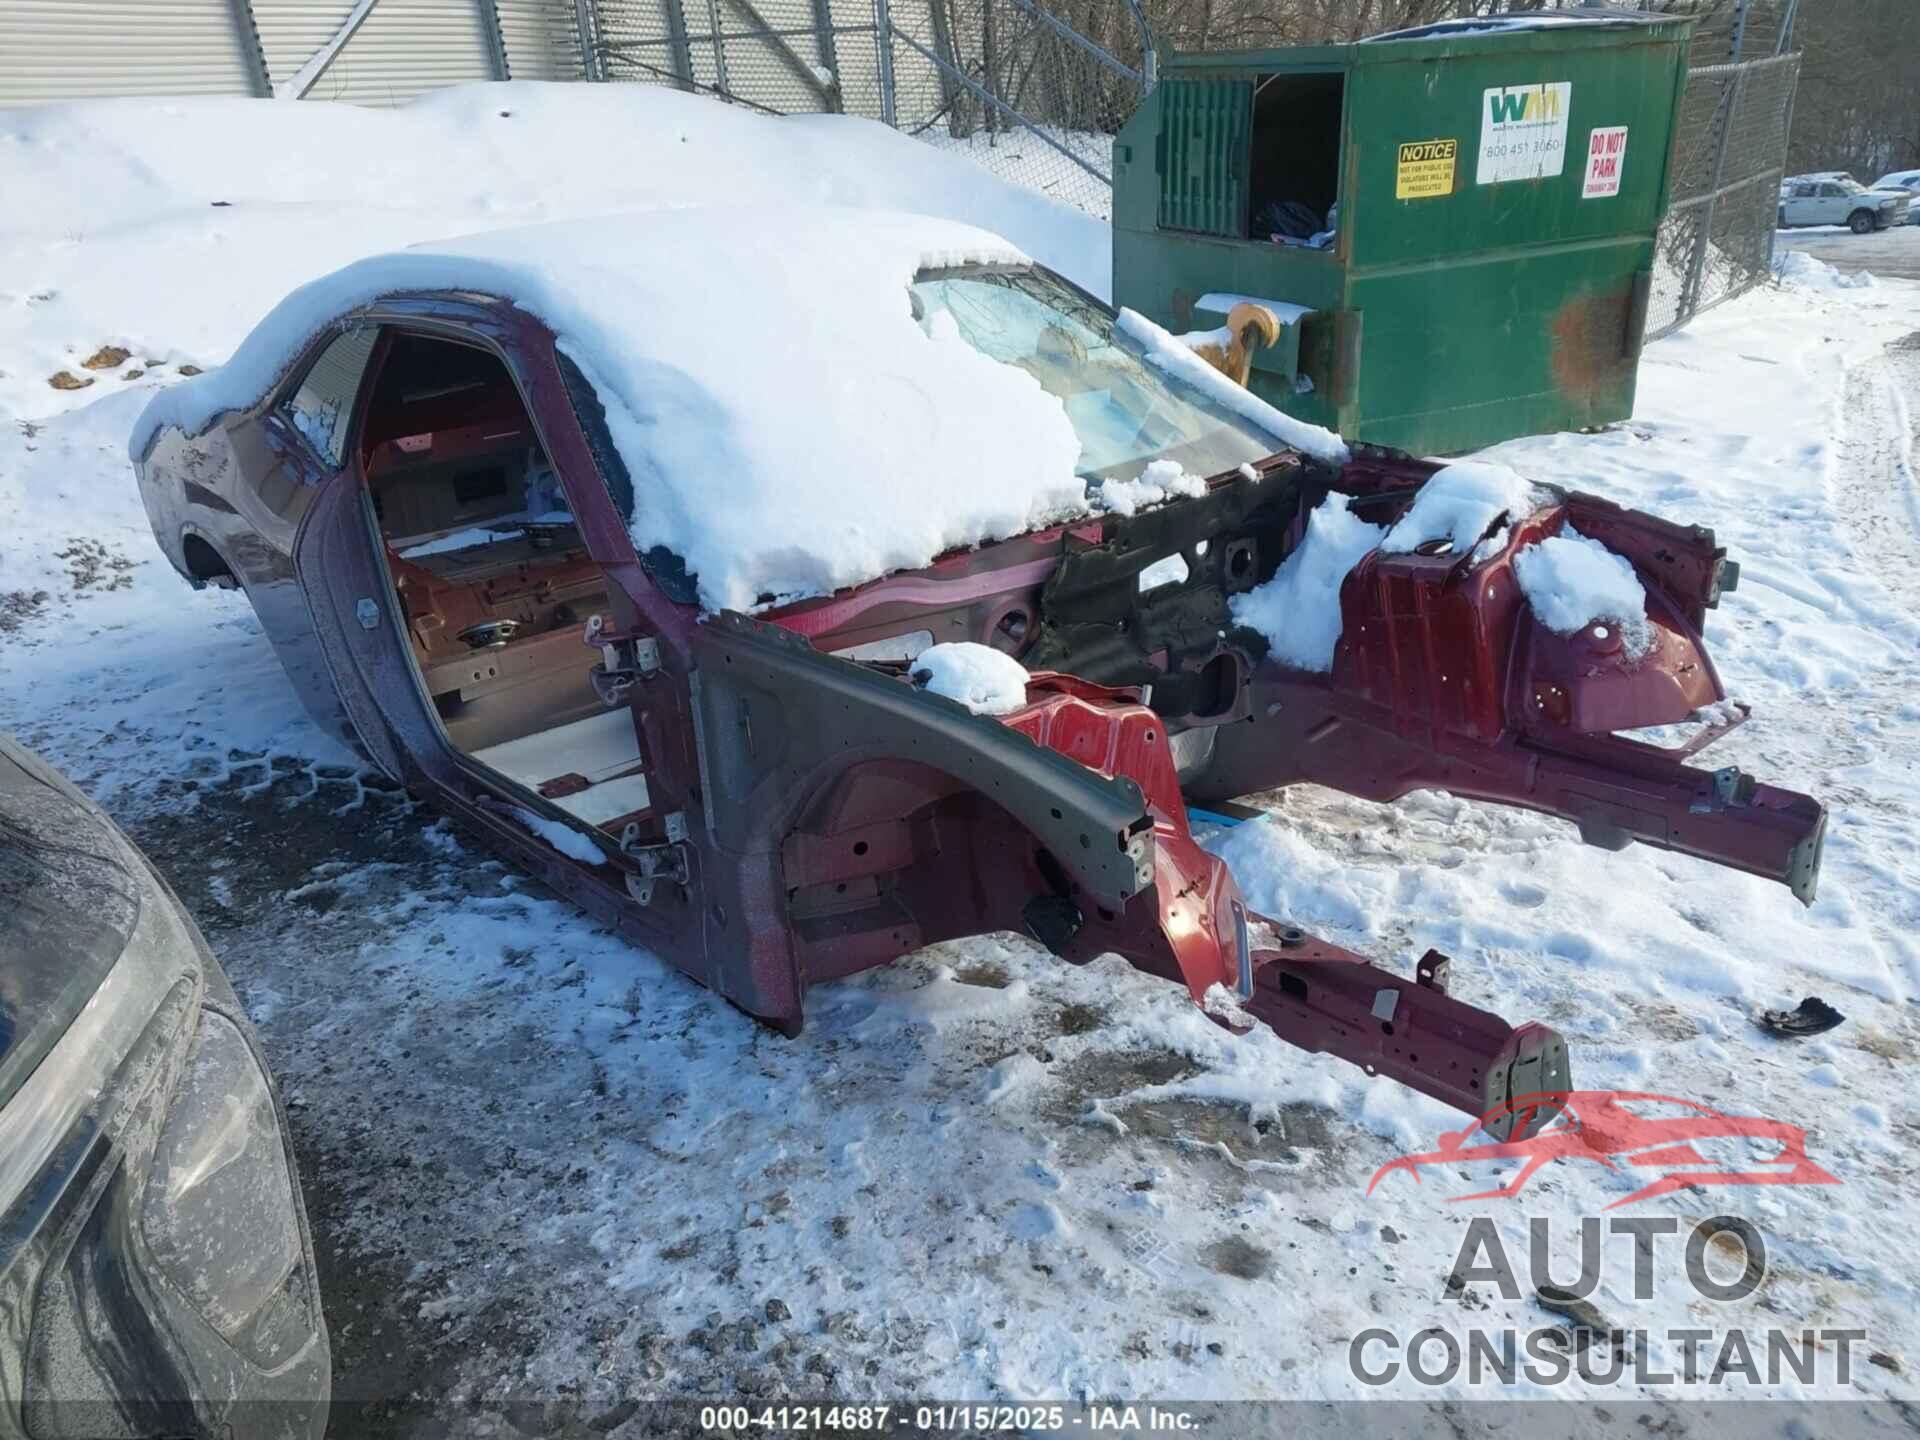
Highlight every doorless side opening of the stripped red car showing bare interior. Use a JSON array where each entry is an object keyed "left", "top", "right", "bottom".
[{"left": 361, "top": 334, "right": 649, "bottom": 835}]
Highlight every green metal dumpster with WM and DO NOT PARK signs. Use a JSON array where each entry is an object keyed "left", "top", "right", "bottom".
[{"left": 1114, "top": 12, "right": 1692, "bottom": 455}]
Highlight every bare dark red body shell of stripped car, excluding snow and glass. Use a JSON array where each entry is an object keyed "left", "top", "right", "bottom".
[{"left": 134, "top": 276, "right": 1826, "bottom": 1144}]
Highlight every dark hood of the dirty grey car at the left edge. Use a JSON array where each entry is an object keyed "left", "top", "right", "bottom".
[{"left": 0, "top": 735, "right": 140, "bottom": 1106}]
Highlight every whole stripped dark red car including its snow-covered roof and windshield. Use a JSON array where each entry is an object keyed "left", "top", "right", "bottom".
[{"left": 131, "top": 211, "right": 1826, "bottom": 1136}]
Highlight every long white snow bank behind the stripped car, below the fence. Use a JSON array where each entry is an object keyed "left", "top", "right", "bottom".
[{"left": 0, "top": 81, "right": 1112, "bottom": 428}]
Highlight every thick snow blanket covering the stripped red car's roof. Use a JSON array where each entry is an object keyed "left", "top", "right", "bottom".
[{"left": 131, "top": 207, "right": 1113, "bottom": 609}]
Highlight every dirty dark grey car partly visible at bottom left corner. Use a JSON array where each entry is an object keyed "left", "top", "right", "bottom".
[{"left": 0, "top": 735, "right": 330, "bottom": 1440}]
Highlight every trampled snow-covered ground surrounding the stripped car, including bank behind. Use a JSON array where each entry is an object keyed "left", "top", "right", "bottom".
[{"left": 0, "top": 86, "right": 1920, "bottom": 1434}]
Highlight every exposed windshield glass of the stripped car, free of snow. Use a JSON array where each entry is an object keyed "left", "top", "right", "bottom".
[{"left": 912, "top": 267, "right": 1275, "bottom": 480}]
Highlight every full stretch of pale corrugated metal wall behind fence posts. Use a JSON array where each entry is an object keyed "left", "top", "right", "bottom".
[{"left": 0, "top": 0, "right": 1021, "bottom": 117}]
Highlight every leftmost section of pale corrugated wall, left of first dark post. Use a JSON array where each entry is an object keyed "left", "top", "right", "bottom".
[{"left": 0, "top": 0, "right": 255, "bottom": 106}]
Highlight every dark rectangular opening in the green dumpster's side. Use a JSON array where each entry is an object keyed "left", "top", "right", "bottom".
[{"left": 1248, "top": 71, "right": 1346, "bottom": 248}]
